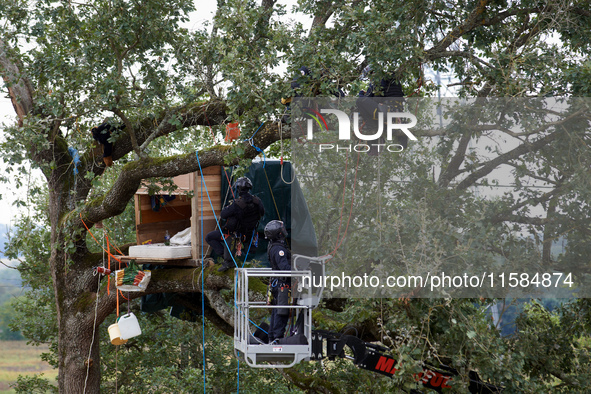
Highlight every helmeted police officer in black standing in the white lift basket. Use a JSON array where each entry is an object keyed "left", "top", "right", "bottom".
[{"left": 265, "top": 220, "right": 291, "bottom": 343}]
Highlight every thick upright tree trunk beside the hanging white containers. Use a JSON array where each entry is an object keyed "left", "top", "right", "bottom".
[{"left": 49, "top": 182, "right": 103, "bottom": 393}]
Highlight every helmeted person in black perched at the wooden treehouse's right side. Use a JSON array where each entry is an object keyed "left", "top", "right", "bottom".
[{"left": 205, "top": 177, "right": 265, "bottom": 272}]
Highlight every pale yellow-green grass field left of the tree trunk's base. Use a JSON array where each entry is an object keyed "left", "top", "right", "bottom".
[{"left": 0, "top": 341, "right": 57, "bottom": 394}]
